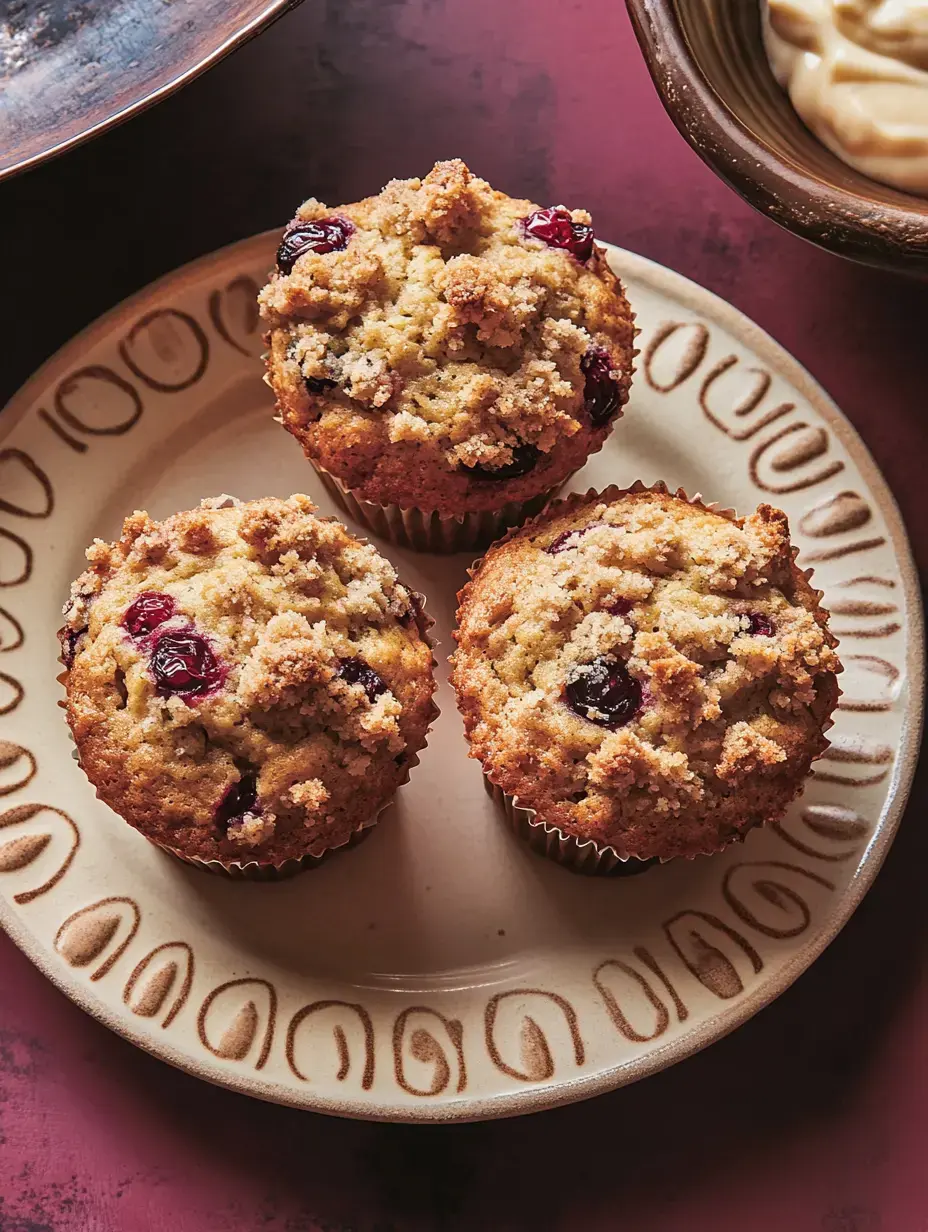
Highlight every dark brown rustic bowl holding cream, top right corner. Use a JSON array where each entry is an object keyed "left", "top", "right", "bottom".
[{"left": 626, "top": 0, "right": 928, "bottom": 275}]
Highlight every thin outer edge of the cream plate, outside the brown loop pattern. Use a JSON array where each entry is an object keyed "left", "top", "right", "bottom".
[{"left": 0, "top": 228, "right": 926, "bottom": 1124}]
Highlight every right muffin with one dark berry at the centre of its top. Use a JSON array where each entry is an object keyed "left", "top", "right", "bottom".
[{"left": 452, "top": 484, "right": 840, "bottom": 871}]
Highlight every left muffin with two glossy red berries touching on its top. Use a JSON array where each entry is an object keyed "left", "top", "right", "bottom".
[{"left": 59, "top": 495, "right": 435, "bottom": 876}]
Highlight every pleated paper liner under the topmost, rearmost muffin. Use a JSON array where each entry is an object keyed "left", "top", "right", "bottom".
[{"left": 309, "top": 458, "right": 571, "bottom": 556}]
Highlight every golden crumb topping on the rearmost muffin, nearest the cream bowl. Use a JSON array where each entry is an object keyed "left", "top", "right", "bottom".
[{"left": 259, "top": 160, "right": 635, "bottom": 507}]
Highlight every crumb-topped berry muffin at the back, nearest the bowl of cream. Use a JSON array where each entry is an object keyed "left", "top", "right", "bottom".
[{"left": 259, "top": 160, "right": 635, "bottom": 551}]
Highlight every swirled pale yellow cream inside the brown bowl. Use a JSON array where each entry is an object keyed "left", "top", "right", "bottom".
[{"left": 764, "top": 0, "right": 928, "bottom": 196}]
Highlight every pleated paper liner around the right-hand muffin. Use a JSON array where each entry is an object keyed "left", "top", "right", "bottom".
[{"left": 458, "top": 479, "right": 842, "bottom": 877}]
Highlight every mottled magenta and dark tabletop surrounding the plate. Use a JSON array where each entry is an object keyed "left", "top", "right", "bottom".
[{"left": 0, "top": 0, "right": 928, "bottom": 1232}]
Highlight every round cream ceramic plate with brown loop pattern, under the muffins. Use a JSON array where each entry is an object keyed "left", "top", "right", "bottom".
[{"left": 0, "top": 237, "right": 922, "bottom": 1121}]
